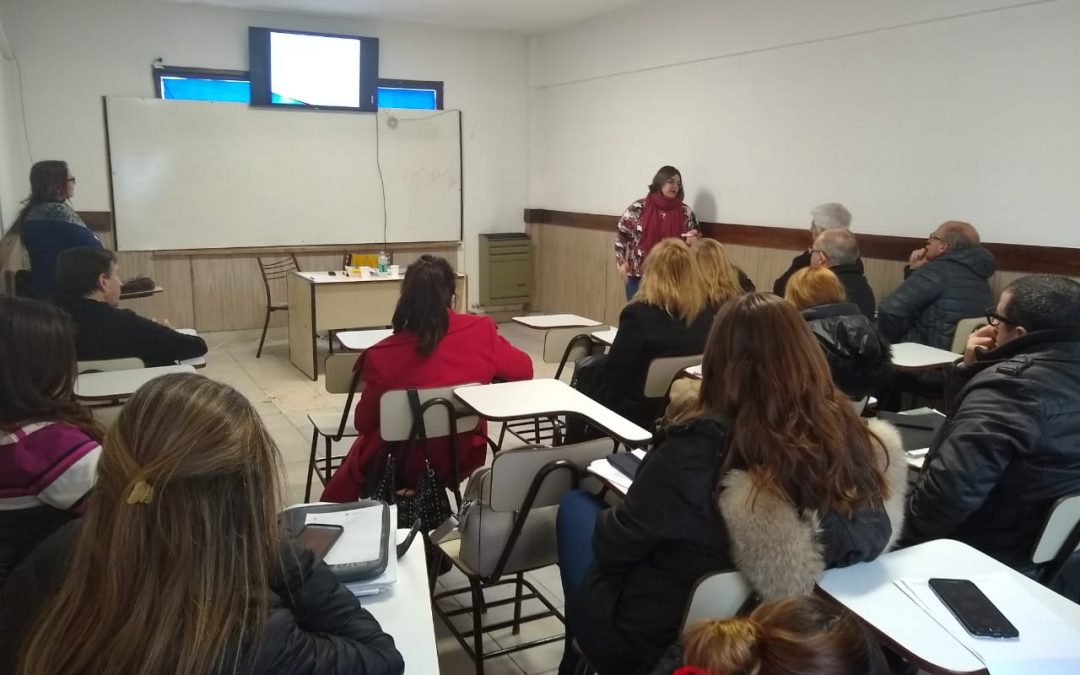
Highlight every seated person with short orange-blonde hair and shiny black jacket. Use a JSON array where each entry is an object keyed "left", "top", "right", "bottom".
[{"left": 784, "top": 266, "right": 892, "bottom": 400}]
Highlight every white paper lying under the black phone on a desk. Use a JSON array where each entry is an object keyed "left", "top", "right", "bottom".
[{"left": 895, "top": 572, "right": 1080, "bottom": 675}]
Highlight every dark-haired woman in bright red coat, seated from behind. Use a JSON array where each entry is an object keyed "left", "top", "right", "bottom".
[{"left": 322, "top": 255, "right": 532, "bottom": 501}]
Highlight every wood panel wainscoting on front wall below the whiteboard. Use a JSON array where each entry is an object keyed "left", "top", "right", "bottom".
[{"left": 0, "top": 211, "right": 461, "bottom": 333}]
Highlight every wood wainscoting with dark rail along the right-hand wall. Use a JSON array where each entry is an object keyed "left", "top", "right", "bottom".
[{"left": 525, "top": 208, "right": 1080, "bottom": 325}]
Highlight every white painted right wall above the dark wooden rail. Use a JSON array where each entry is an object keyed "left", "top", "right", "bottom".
[{"left": 529, "top": 0, "right": 1080, "bottom": 246}]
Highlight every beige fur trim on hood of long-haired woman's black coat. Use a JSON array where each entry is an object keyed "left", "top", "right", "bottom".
[{"left": 717, "top": 420, "right": 907, "bottom": 599}]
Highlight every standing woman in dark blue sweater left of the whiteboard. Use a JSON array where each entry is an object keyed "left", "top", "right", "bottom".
[{"left": 11, "top": 160, "right": 102, "bottom": 298}]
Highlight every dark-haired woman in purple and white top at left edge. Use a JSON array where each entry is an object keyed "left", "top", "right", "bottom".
[{"left": 0, "top": 296, "right": 105, "bottom": 586}]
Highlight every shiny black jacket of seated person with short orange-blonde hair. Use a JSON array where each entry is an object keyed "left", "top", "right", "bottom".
[{"left": 802, "top": 302, "right": 892, "bottom": 399}]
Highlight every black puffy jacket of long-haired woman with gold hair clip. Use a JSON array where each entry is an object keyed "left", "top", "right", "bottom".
[{"left": 0, "top": 521, "right": 405, "bottom": 675}]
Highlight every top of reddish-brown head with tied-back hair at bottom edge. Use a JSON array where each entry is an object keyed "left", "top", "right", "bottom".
[{"left": 664, "top": 596, "right": 891, "bottom": 675}]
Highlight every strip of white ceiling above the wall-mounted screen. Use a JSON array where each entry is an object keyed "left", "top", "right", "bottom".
[{"left": 160, "top": 0, "right": 644, "bottom": 32}]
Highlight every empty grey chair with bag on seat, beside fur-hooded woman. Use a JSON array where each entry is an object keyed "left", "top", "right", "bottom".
[{"left": 432, "top": 438, "right": 611, "bottom": 675}]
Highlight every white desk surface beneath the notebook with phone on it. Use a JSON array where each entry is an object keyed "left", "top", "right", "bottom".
[{"left": 360, "top": 529, "right": 438, "bottom": 675}]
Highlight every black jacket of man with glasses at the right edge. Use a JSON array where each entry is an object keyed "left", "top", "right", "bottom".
[{"left": 905, "top": 329, "right": 1080, "bottom": 567}]
